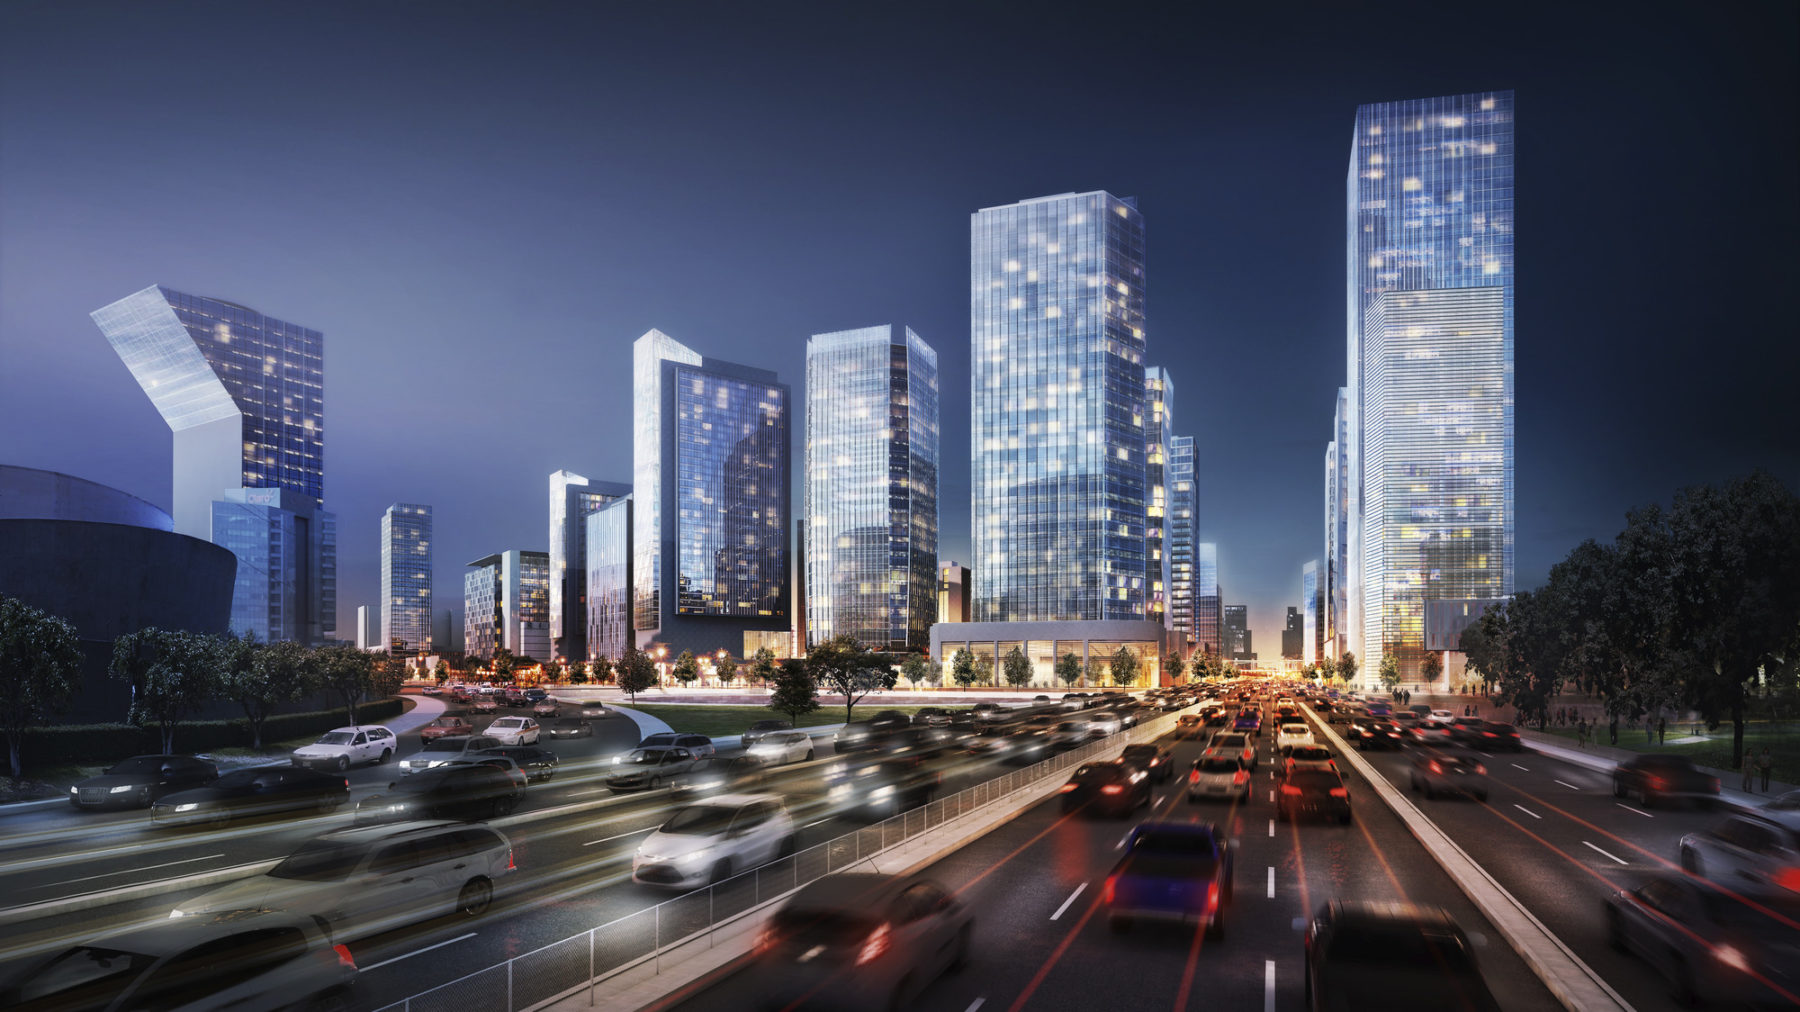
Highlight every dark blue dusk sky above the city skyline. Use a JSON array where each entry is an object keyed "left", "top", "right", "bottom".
[{"left": 0, "top": 0, "right": 1800, "bottom": 641}]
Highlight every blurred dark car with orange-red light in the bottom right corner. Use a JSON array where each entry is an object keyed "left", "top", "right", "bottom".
[{"left": 1606, "top": 873, "right": 1800, "bottom": 1008}]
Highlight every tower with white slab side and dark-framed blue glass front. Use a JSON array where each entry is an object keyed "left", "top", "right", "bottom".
[{"left": 632, "top": 330, "right": 792, "bottom": 654}]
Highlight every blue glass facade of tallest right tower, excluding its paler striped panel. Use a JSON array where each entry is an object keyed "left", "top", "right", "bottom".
[{"left": 1337, "top": 92, "right": 1514, "bottom": 672}]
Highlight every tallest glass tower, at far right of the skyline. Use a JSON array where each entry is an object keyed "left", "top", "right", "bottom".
[{"left": 1339, "top": 92, "right": 1514, "bottom": 679}]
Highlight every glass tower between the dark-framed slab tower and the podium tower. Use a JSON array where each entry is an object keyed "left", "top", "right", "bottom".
[{"left": 805, "top": 326, "right": 938, "bottom": 652}]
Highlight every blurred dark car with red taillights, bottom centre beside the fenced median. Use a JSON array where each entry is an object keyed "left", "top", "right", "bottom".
[{"left": 745, "top": 872, "right": 974, "bottom": 1008}]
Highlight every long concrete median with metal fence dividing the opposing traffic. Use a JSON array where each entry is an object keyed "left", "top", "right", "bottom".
[{"left": 376, "top": 713, "right": 1175, "bottom": 1012}]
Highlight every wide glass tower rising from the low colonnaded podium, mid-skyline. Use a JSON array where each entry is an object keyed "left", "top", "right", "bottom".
[{"left": 968, "top": 191, "right": 1150, "bottom": 623}]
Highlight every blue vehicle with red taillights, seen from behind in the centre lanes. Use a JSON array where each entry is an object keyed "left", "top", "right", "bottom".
[{"left": 1102, "top": 823, "right": 1231, "bottom": 942}]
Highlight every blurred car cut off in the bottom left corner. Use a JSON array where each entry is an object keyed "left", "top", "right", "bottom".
[{"left": 0, "top": 911, "right": 356, "bottom": 1012}]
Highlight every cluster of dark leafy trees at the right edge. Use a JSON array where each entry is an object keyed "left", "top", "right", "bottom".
[{"left": 1460, "top": 470, "right": 1800, "bottom": 762}]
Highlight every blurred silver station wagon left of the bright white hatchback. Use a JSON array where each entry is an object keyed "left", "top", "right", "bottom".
[{"left": 169, "top": 821, "right": 515, "bottom": 940}]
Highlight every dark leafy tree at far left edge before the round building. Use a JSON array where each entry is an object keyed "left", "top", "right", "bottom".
[{"left": 0, "top": 598, "right": 81, "bottom": 780}]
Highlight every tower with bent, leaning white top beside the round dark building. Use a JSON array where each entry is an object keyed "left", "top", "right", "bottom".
[{"left": 90, "top": 285, "right": 337, "bottom": 643}]
